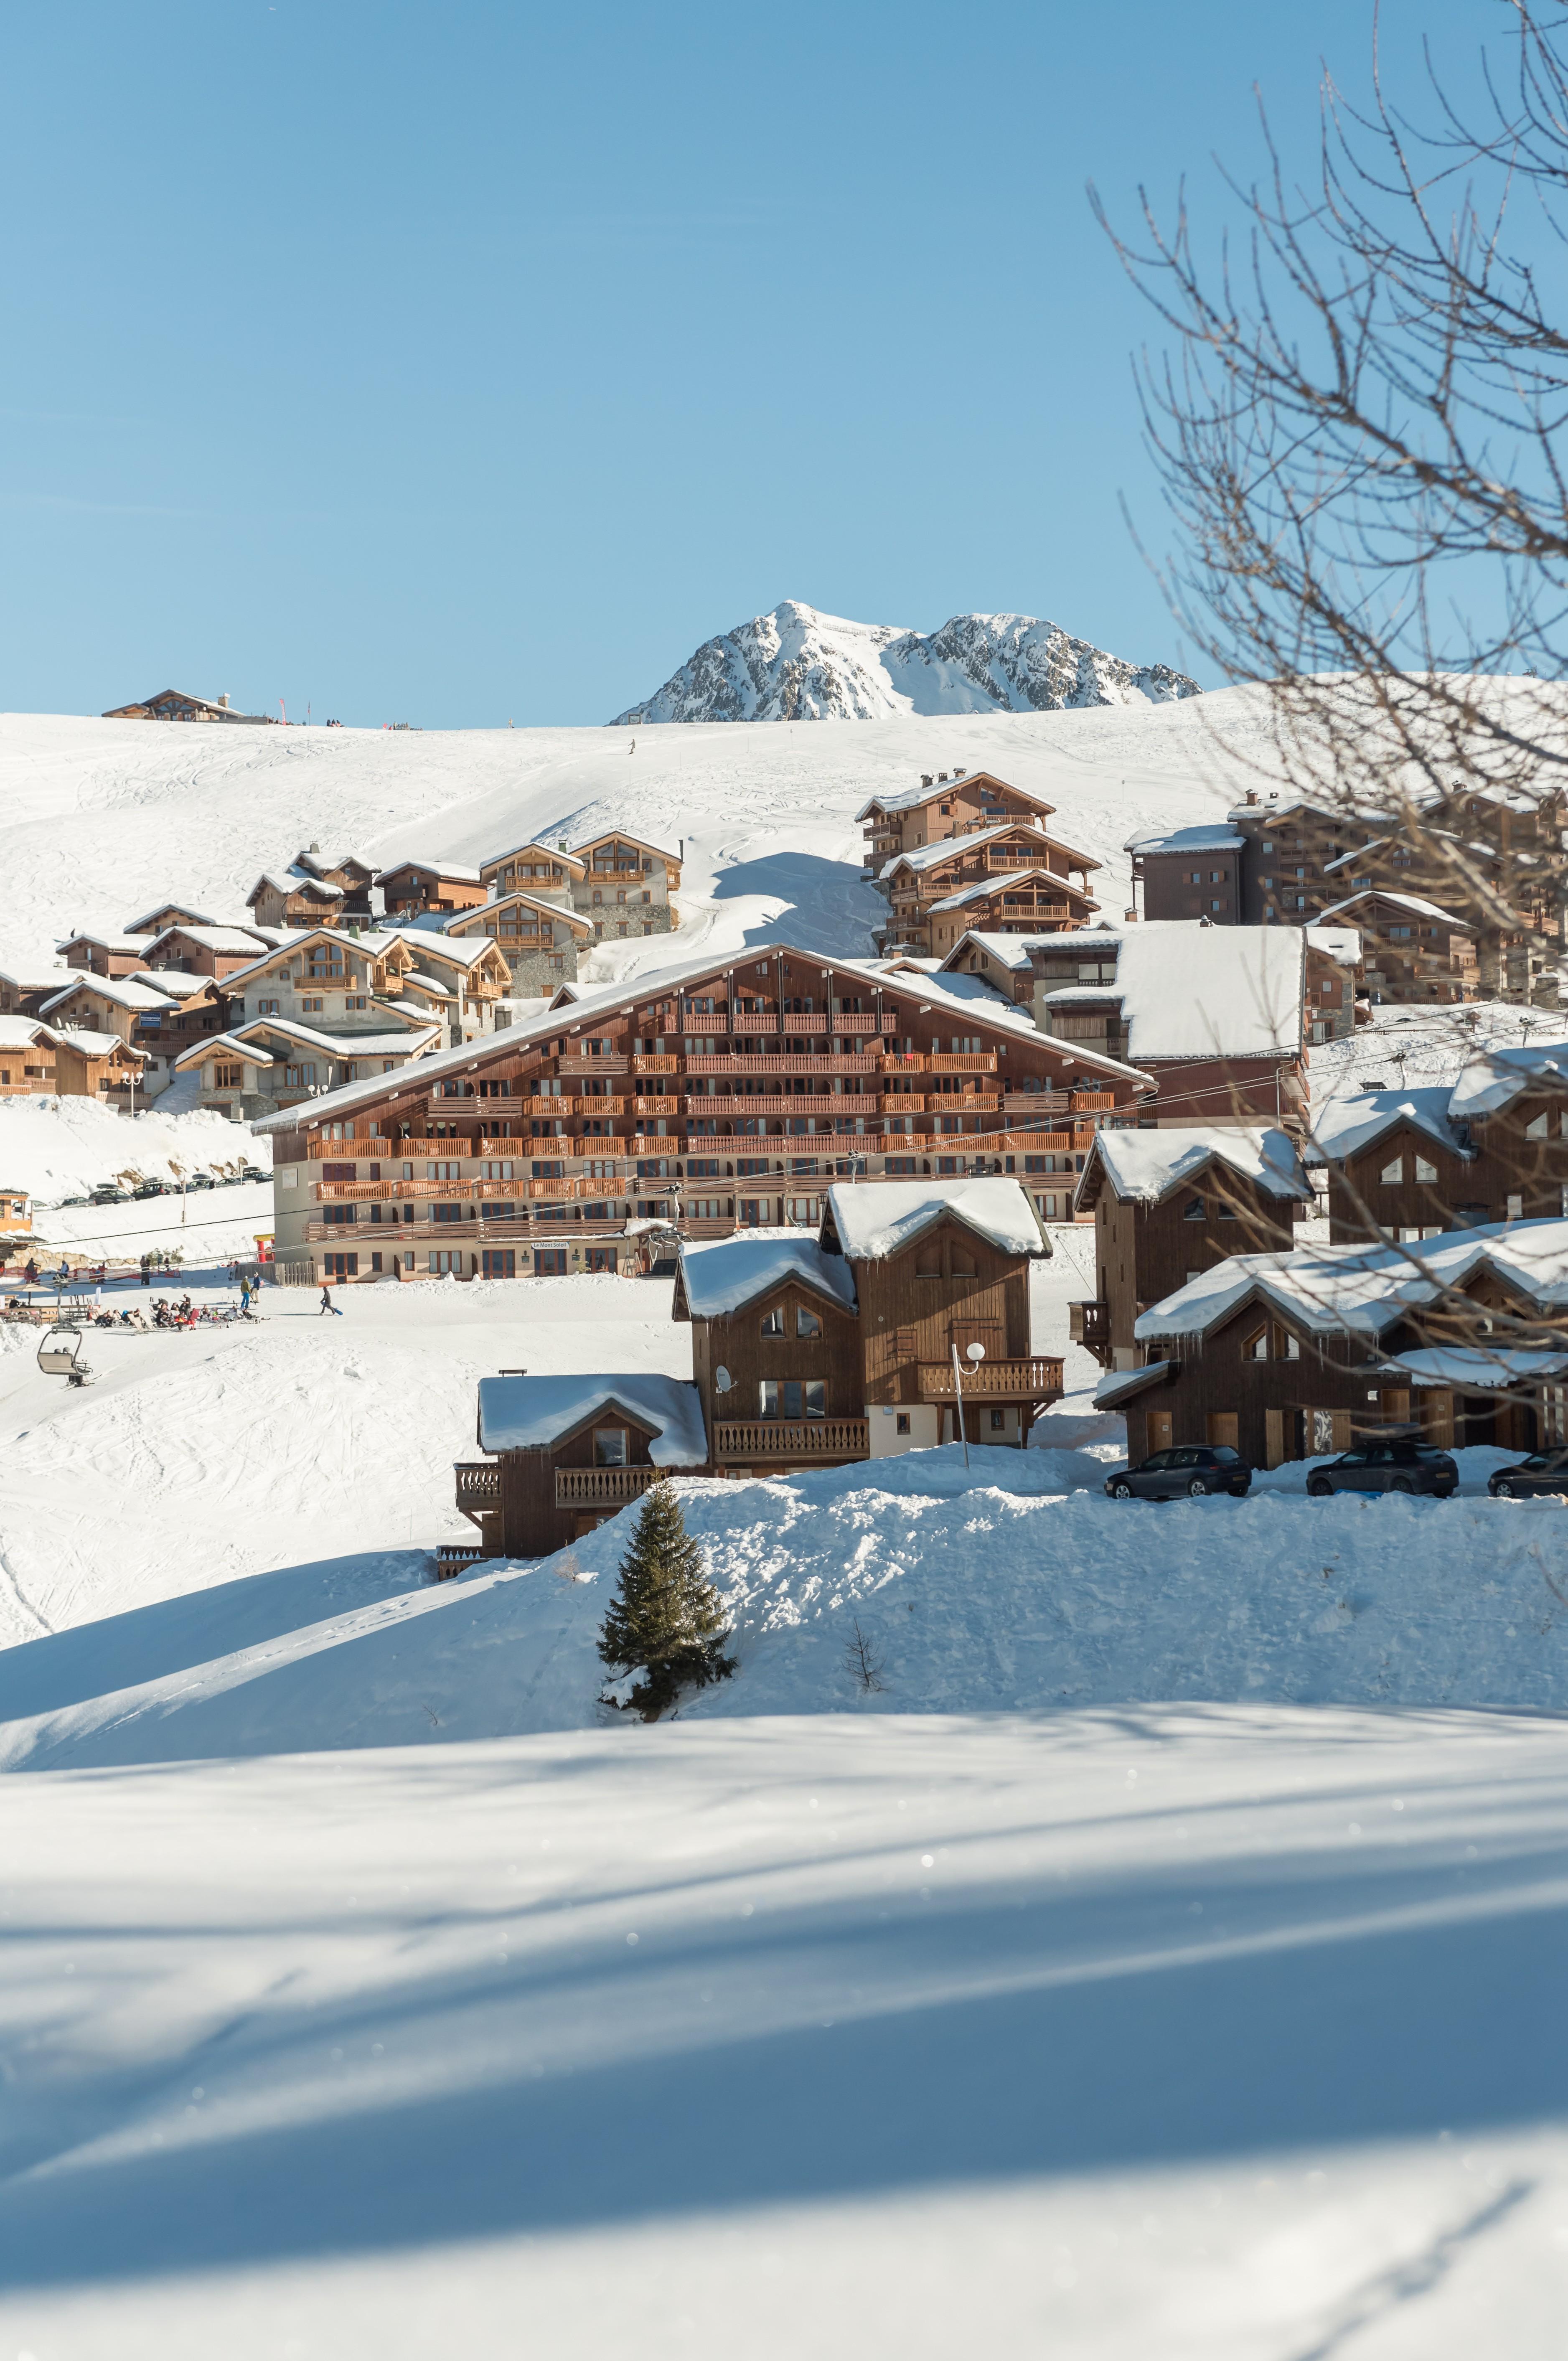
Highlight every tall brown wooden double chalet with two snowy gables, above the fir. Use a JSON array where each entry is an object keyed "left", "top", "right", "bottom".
[{"left": 673, "top": 1178, "right": 1062, "bottom": 1476}]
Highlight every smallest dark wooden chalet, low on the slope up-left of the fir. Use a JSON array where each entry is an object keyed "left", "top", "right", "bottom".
[{"left": 437, "top": 1370, "right": 709, "bottom": 1575}]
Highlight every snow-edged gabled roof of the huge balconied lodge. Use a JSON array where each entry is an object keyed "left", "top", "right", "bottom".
[{"left": 254, "top": 928, "right": 1152, "bottom": 1128}]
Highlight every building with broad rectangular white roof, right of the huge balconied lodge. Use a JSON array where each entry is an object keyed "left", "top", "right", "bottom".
[{"left": 1029, "top": 921, "right": 1306, "bottom": 1131}]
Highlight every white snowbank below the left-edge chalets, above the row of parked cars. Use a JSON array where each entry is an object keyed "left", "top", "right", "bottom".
[{"left": 0, "top": 1098, "right": 272, "bottom": 1204}]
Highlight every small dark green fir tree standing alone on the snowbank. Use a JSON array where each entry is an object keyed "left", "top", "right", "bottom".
[{"left": 600, "top": 1478, "right": 734, "bottom": 1721}]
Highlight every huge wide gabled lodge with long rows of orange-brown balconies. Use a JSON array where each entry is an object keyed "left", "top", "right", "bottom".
[{"left": 248, "top": 935, "right": 1150, "bottom": 1277}]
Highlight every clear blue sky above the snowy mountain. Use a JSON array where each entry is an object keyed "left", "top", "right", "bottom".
[{"left": 0, "top": 0, "right": 1502, "bottom": 727}]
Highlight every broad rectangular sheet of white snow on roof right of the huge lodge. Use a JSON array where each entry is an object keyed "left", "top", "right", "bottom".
[{"left": 1046, "top": 925, "right": 1306, "bottom": 1065}]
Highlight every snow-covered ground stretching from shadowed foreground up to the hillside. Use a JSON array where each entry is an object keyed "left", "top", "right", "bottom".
[{"left": 0, "top": 701, "right": 1568, "bottom": 2361}]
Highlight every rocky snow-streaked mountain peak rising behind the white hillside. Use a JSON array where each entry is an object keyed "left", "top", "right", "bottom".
[{"left": 614, "top": 600, "right": 1200, "bottom": 727}]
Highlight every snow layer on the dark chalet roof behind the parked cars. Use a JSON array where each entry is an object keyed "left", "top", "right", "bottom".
[{"left": 1133, "top": 1221, "right": 1568, "bottom": 1341}]
